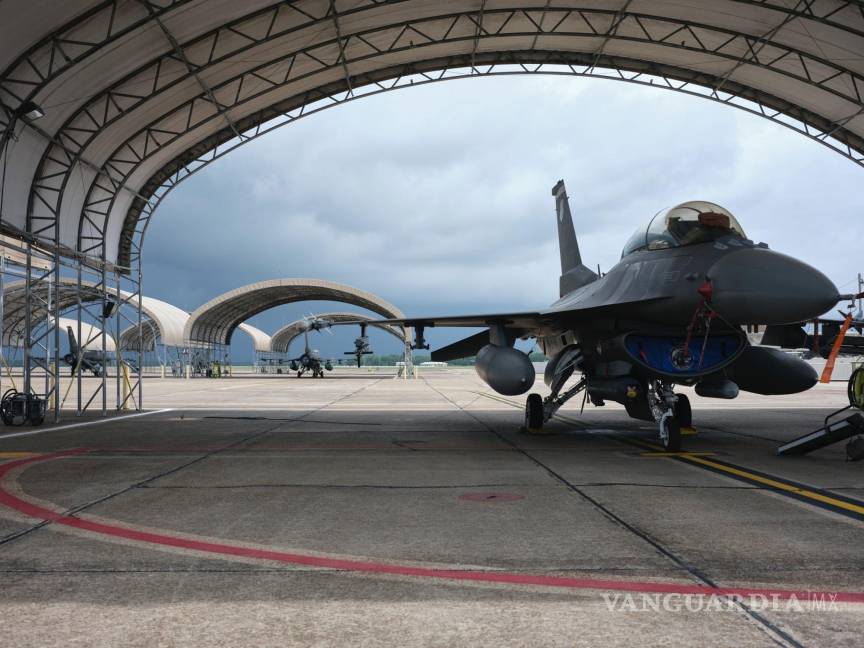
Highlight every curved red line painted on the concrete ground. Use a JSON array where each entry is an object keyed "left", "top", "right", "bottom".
[{"left": 0, "top": 450, "right": 864, "bottom": 603}]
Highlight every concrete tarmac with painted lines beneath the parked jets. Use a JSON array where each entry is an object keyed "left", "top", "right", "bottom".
[{"left": 0, "top": 369, "right": 864, "bottom": 646}]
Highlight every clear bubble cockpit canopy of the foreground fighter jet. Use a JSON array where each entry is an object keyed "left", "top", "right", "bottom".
[{"left": 621, "top": 201, "right": 747, "bottom": 256}]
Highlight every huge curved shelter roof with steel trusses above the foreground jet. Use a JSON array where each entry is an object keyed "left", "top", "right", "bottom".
[{"left": 0, "top": 0, "right": 864, "bottom": 266}]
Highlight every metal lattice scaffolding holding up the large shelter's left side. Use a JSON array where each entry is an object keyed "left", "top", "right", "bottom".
[{"left": 0, "top": 237, "right": 143, "bottom": 422}]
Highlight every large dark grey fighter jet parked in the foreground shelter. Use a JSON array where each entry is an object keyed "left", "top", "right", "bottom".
[{"left": 340, "top": 180, "right": 852, "bottom": 451}]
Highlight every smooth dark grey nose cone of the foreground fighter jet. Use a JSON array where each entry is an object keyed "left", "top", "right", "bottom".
[{"left": 707, "top": 248, "right": 840, "bottom": 324}]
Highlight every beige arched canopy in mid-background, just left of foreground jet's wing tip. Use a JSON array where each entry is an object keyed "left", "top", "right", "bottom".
[{"left": 183, "top": 279, "right": 405, "bottom": 351}]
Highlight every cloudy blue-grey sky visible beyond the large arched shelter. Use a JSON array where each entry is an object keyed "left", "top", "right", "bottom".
[{"left": 144, "top": 76, "right": 864, "bottom": 356}]
